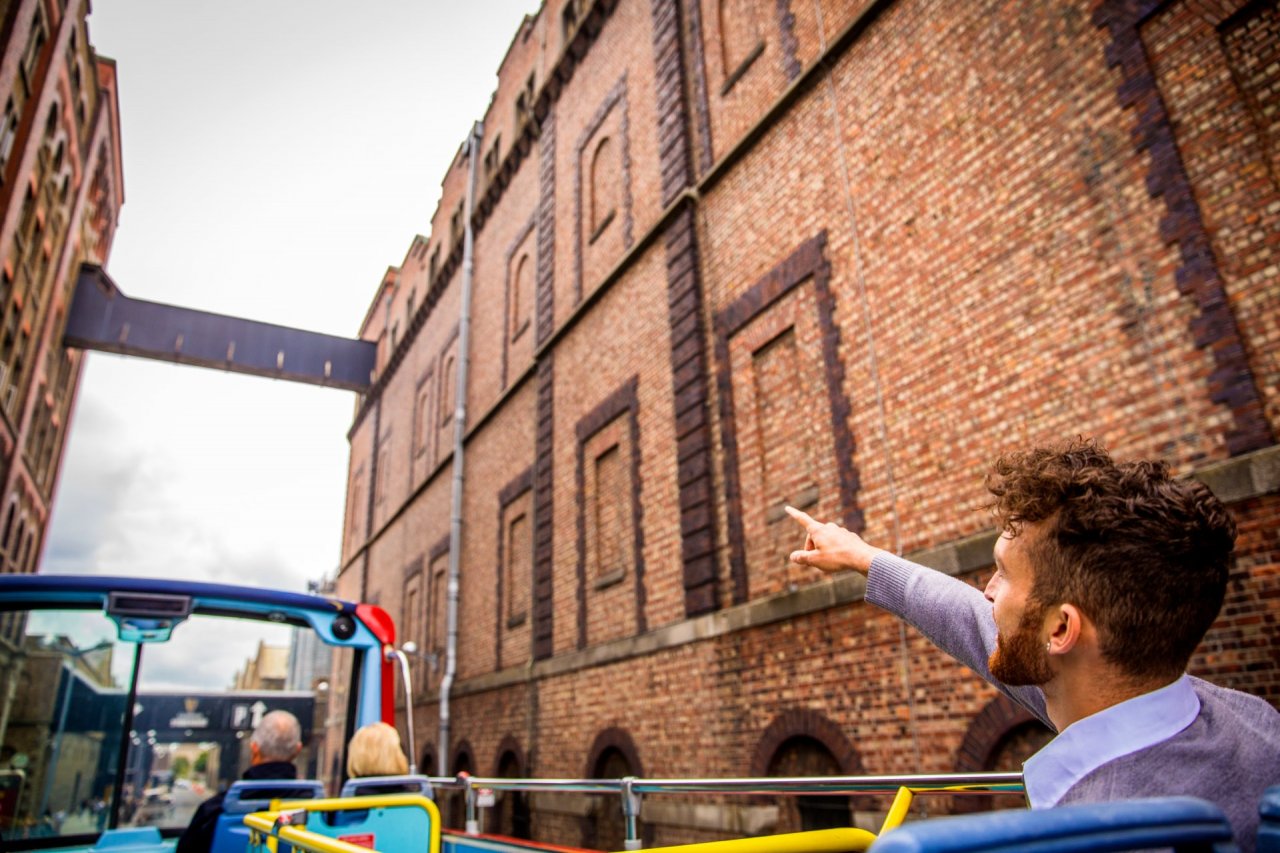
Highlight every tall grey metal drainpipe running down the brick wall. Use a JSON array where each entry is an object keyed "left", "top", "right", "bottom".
[{"left": 439, "top": 122, "right": 484, "bottom": 776}]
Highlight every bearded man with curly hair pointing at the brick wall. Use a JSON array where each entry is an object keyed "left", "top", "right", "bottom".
[{"left": 787, "top": 441, "right": 1280, "bottom": 850}]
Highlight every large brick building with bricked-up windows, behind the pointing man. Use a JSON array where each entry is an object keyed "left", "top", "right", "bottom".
[{"left": 332, "top": 0, "right": 1280, "bottom": 849}]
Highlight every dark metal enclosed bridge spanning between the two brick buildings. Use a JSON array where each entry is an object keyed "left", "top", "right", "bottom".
[{"left": 63, "top": 264, "right": 376, "bottom": 392}]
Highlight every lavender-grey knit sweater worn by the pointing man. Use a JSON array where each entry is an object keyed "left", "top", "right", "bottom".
[{"left": 867, "top": 555, "right": 1280, "bottom": 853}]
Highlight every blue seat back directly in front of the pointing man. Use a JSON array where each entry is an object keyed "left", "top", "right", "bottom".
[{"left": 872, "top": 797, "right": 1235, "bottom": 853}]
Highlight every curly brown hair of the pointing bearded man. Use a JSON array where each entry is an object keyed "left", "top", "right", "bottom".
[{"left": 987, "top": 438, "right": 1235, "bottom": 679}]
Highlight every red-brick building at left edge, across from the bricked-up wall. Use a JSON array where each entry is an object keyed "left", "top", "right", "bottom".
[{"left": 0, "top": 0, "right": 124, "bottom": 717}]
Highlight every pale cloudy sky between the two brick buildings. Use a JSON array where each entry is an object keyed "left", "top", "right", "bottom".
[{"left": 44, "top": 0, "right": 538, "bottom": 686}]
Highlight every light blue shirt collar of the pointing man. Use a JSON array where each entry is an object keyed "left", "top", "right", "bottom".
[{"left": 1023, "top": 674, "right": 1199, "bottom": 808}]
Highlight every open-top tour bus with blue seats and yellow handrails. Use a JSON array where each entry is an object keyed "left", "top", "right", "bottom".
[{"left": 0, "top": 575, "right": 1254, "bottom": 853}]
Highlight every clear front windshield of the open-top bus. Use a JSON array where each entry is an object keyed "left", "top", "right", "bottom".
[{"left": 0, "top": 608, "right": 351, "bottom": 841}]
